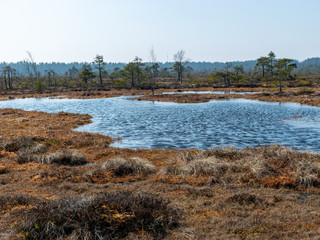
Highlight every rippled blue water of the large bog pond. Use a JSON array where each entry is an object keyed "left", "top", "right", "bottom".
[{"left": 0, "top": 94, "right": 320, "bottom": 152}]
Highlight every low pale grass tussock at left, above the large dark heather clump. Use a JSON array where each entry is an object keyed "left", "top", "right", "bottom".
[{"left": 17, "top": 150, "right": 88, "bottom": 166}]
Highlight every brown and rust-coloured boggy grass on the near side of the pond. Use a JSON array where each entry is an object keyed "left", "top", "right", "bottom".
[{"left": 0, "top": 109, "right": 320, "bottom": 239}]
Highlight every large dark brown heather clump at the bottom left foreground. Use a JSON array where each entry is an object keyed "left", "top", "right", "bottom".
[{"left": 16, "top": 192, "right": 180, "bottom": 239}]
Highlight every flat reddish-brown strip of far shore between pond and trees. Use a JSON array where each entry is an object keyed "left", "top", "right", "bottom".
[{"left": 0, "top": 87, "right": 320, "bottom": 107}]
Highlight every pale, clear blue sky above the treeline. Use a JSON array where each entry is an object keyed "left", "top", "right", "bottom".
[{"left": 0, "top": 0, "right": 320, "bottom": 62}]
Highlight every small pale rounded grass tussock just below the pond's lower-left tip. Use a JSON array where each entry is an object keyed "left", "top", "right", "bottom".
[{"left": 102, "top": 158, "right": 156, "bottom": 177}]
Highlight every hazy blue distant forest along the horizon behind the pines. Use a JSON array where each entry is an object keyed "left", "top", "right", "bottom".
[{"left": 0, "top": 57, "right": 320, "bottom": 75}]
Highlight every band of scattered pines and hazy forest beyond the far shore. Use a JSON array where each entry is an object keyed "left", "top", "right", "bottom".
[{"left": 0, "top": 50, "right": 320, "bottom": 92}]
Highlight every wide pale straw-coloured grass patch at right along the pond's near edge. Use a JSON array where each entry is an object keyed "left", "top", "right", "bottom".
[{"left": 166, "top": 145, "right": 320, "bottom": 187}]
